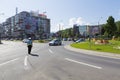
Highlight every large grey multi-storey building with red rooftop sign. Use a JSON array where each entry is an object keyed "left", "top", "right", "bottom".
[{"left": 2, "top": 11, "right": 50, "bottom": 39}]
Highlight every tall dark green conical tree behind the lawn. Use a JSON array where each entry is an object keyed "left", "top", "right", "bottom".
[{"left": 104, "top": 16, "right": 117, "bottom": 38}]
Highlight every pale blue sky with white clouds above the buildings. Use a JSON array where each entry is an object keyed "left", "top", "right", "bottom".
[{"left": 0, "top": 0, "right": 120, "bottom": 32}]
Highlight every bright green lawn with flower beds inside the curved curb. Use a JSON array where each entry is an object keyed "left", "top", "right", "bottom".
[{"left": 71, "top": 40, "right": 120, "bottom": 54}]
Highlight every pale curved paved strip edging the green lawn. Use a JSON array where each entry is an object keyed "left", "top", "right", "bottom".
[{"left": 65, "top": 45, "right": 120, "bottom": 59}]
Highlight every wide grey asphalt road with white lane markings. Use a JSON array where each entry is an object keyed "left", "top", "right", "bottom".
[{"left": 0, "top": 41, "right": 120, "bottom": 80}]
